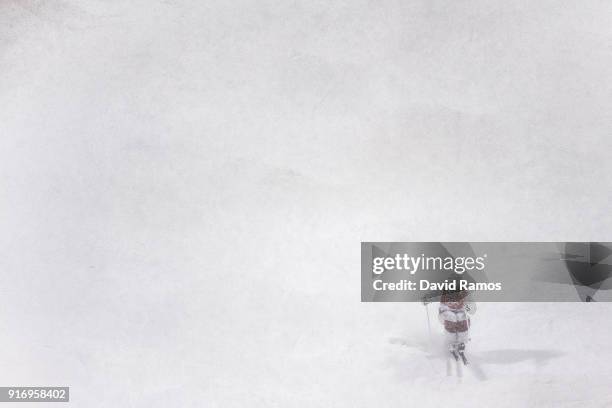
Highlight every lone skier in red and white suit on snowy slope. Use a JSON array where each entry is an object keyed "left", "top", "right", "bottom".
[{"left": 438, "top": 291, "right": 476, "bottom": 364}]
